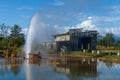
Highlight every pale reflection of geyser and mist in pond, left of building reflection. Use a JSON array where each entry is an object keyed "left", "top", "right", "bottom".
[{"left": 25, "top": 60, "right": 68, "bottom": 80}]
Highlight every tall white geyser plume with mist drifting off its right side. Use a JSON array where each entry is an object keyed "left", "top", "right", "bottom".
[{"left": 24, "top": 13, "right": 56, "bottom": 58}]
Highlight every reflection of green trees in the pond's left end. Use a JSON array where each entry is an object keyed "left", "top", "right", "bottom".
[{"left": 0, "top": 59, "right": 23, "bottom": 76}]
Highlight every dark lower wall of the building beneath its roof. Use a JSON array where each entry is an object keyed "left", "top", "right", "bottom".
[{"left": 56, "top": 37, "right": 96, "bottom": 51}]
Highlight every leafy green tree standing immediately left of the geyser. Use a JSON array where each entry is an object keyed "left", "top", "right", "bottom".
[{"left": 6, "top": 25, "right": 25, "bottom": 57}]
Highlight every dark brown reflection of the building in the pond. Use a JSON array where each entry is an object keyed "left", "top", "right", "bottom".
[{"left": 55, "top": 59, "right": 98, "bottom": 80}]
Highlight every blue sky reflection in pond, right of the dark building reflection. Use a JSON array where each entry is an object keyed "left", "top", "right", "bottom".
[{"left": 97, "top": 61, "right": 120, "bottom": 80}]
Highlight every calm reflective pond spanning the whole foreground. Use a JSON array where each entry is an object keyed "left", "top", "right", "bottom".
[{"left": 0, "top": 58, "right": 120, "bottom": 80}]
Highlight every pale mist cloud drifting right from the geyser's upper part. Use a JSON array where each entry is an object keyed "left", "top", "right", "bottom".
[{"left": 29, "top": 13, "right": 56, "bottom": 42}]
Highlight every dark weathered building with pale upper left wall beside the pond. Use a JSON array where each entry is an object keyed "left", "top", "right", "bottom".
[{"left": 54, "top": 29, "right": 98, "bottom": 51}]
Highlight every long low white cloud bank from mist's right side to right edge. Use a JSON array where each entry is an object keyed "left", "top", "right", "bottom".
[{"left": 56, "top": 16, "right": 120, "bottom": 35}]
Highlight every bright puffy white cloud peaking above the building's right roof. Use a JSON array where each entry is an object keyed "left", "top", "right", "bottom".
[{"left": 75, "top": 17, "right": 120, "bottom": 35}]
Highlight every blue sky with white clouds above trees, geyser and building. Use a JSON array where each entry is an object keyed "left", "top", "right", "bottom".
[{"left": 0, "top": 0, "right": 120, "bottom": 35}]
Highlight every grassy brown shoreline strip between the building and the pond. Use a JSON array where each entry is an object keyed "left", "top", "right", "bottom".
[{"left": 0, "top": 53, "right": 120, "bottom": 63}]
